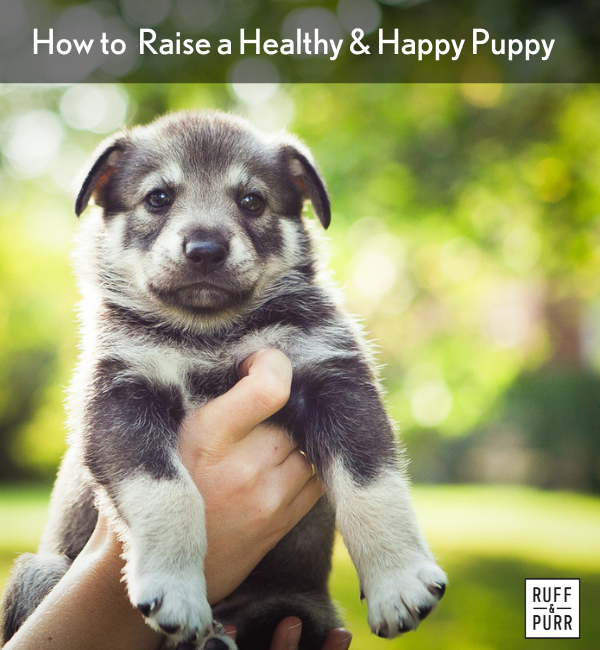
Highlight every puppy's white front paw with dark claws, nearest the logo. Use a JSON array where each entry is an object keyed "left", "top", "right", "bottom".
[{"left": 366, "top": 558, "right": 447, "bottom": 639}]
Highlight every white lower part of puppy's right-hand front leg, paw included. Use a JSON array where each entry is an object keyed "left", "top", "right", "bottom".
[{"left": 327, "top": 460, "right": 446, "bottom": 638}]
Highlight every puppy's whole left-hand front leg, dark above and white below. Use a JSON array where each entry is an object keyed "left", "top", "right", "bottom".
[{"left": 83, "top": 364, "right": 235, "bottom": 648}]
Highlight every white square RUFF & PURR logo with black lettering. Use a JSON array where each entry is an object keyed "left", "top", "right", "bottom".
[{"left": 525, "top": 579, "right": 579, "bottom": 639}]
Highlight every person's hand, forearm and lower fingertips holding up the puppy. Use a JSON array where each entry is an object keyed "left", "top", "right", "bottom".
[{"left": 1, "top": 350, "right": 332, "bottom": 650}]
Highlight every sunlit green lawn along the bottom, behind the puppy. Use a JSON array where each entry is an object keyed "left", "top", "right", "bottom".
[{"left": 0, "top": 486, "right": 600, "bottom": 650}]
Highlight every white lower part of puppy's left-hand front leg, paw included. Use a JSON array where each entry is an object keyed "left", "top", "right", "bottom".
[{"left": 116, "top": 470, "right": 212, "bottom": 641}]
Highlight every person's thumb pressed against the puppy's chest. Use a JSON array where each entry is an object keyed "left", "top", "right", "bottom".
[{"left": 187, "top": 350, "right": 292, "bottom": 443}]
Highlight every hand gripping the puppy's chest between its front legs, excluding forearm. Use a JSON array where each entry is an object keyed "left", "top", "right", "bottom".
[{"left": 179, "top": 350, "right": 324, "bottom": 604}]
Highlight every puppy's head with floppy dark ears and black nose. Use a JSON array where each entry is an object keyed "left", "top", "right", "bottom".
[{"left": 76, "top": 113, "right": 330, "bottom": 318}]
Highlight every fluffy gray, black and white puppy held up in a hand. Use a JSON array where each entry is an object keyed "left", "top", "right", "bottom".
[{"left": 3, "top": 112, "right": 446, "bottom": 650}]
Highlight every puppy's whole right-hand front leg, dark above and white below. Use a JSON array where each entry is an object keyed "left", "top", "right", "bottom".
[{"left": 277, "top": 360, "right": 446, "bottom": 637}]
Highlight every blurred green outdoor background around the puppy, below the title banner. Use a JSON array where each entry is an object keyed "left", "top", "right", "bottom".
[{"left": 0, "top": 83, "right": 600, "bottom": 650}]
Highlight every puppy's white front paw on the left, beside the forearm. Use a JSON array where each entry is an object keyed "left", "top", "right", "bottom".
[{"left": 129, "top": 575, "right": 212, "bottom": 643}]
